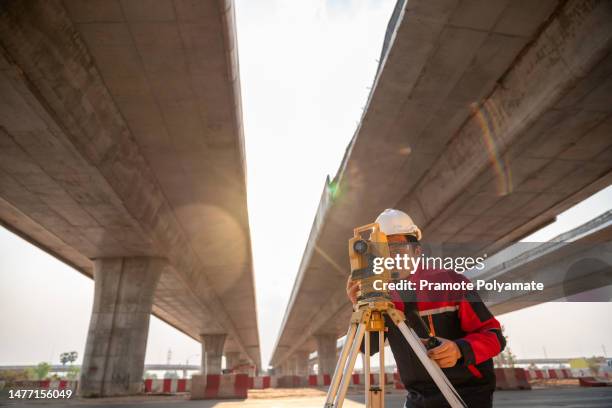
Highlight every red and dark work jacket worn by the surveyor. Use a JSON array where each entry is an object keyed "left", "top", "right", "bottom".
[{"left": 360, "top": 270, "right": 506, "bottom": 407}]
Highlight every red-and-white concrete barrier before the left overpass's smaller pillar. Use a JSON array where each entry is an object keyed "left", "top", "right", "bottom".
[{"left": 191, "top": 374, "right": 249, "bottom": 400}]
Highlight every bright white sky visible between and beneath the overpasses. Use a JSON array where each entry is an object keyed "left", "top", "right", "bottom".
[{"left": 0, "top": 0, "right": 612, "bottom": 365}]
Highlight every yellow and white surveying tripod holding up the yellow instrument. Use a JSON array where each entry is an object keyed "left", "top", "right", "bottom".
[{"left": 325, "top": 300, "right": 466, "bottom": 408}]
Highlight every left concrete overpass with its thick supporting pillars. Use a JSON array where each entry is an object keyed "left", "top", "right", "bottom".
[{"left": 0, "top": 0, "right": 260, "bottom": 396}]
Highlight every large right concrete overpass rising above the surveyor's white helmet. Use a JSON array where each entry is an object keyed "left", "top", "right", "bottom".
[{"left": 270, "top": 0, "right": 612, "bottom": 374}]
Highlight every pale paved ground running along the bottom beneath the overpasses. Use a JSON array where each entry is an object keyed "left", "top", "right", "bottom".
[{"left": 0, "top": 387, "right": 612, "bottom": 408}]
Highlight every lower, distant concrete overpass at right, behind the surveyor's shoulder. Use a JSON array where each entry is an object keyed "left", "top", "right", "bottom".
[{"left": 466, "top": 211, "right": 612, "bottom": 314}]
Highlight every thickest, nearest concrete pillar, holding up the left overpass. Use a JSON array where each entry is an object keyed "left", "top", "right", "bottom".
[{"left": 79, "top": 257, "right": 167, "bottom": 397}]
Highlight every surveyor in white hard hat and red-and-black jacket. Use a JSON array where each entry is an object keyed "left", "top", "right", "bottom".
[{"left": 346, "top": 209, "right": 506, "bottom": 408}]
